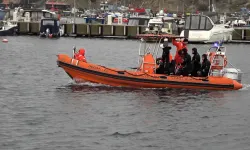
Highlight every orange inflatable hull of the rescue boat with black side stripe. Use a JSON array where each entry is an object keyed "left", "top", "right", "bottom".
[{"left": 57, "top": 55, "right": 242, "bottom": 90}]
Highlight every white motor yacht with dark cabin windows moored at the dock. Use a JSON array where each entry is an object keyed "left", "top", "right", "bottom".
[{"left": 180, "top": 13, "right": 234, "bottom": 43}]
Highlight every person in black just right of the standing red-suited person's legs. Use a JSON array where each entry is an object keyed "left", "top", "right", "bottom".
[{"left": 177, "top": 48, "right": 192, "bottom": 76}]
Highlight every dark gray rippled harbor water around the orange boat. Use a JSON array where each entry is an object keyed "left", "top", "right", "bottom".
[{"left": 0, "top": 36, "right": 250, "bottom": 150}]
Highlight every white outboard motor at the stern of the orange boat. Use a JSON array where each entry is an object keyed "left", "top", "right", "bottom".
[{"left": 223, "top": 68, "right": 243, "bottom": 83}]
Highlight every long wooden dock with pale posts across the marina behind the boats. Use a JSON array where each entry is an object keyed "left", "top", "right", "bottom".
[{"left": 13, "top": 22, "right": 250, "bottom": 43}]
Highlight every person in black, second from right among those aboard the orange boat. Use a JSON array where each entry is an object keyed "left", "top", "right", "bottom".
[{"left": 191, "top": 48, "right": 201, "bottom": 77}]
